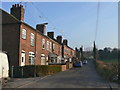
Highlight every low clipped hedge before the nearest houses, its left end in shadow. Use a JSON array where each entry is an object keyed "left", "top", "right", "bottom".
[{"left": 13, "top": 65, "right": 61, "bottom": 78}]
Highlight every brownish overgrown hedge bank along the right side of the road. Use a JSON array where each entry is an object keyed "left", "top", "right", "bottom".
[{"left": 95, "top": 60, "right": 120, "bottom": 83}]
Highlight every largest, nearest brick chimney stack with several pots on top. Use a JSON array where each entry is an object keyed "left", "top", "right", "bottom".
[{"left": 10, "top": 4, "right": 24, "bottom": 21}]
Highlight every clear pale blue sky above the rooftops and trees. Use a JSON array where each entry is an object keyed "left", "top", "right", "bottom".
[{"left": 1, "top": 2, "right": 118, "bottom": 48}]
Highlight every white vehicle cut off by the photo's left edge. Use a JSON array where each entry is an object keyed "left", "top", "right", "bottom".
[{"left": 0, "top": 51, "right": 9, "bottom": 85}]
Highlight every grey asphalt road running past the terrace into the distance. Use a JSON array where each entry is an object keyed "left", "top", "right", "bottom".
[{"left": 15, "top": 61, "right": 118, "bottom": 88}]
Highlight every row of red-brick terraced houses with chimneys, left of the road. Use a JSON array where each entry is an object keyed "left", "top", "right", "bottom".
[{"left": 0, "top": 4, "right": 76, "bottom": 66}]
